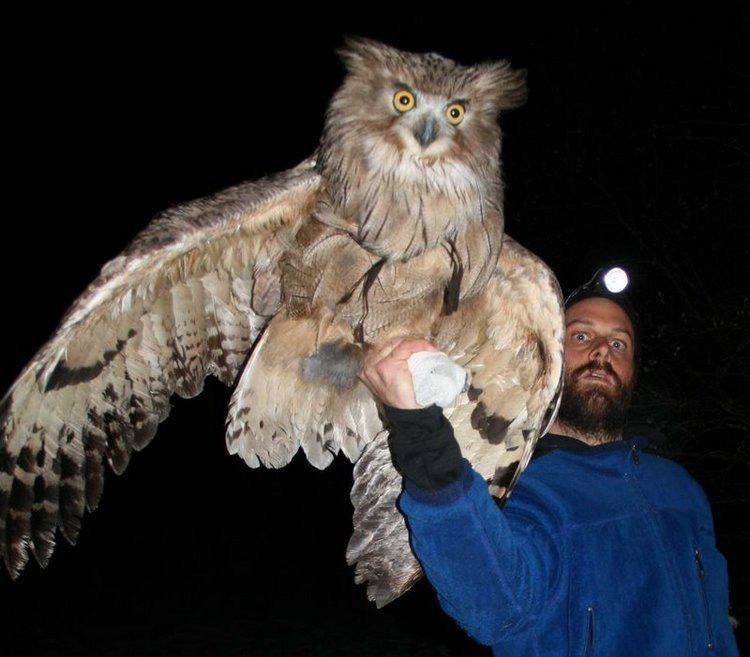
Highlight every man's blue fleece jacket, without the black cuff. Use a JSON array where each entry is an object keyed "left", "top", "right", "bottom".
[{"left": 399, "top": 437, "right": 738, "bottom": 657}]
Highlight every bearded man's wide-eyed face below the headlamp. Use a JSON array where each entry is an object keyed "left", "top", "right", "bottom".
[{"left": 559, "top": 297, "right": 634, "bottom": 440}]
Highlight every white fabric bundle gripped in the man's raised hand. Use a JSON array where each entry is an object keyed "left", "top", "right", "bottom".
[{"left": 406, "top": 351, "right": 469, "bottom": 408}]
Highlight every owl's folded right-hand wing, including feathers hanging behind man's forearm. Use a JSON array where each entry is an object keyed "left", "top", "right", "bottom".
[{"left": 347, "top": 236, "right": 564, "bottom": 607}]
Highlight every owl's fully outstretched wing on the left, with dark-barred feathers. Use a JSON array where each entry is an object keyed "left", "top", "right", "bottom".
[{"left": 0, "top": 158, "right": 320, "bottom": 578}]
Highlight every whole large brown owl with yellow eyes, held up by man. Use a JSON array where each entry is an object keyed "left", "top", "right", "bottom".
[{"left": 0, "top": 39, "right": 563, "bottom": 605}]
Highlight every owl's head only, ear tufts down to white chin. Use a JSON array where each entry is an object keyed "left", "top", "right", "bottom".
[{"left": 321, "top": 38, "right": 526, "bottom": 190}]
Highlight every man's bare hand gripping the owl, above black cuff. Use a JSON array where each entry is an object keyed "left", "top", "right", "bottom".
[{"left": 359, "top": 338, "right": 438, "bottom": 409}]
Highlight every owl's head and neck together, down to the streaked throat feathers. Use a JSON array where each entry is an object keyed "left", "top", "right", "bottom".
[{"left": 317, "top": 38, "right": 525, "bottom": 262}]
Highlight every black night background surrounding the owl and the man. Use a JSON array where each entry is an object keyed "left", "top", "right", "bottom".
[{"left": 0, "top": 1, "right": 750, "bottom": 657}]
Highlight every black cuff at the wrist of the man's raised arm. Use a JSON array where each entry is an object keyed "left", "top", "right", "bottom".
[{"left": 383, "top": 404, "right": 463, "bottom": 490}]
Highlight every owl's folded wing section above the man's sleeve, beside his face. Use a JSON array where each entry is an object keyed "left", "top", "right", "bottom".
[{"left": 451, "top": 235, "right": 565, "bottom": 494}]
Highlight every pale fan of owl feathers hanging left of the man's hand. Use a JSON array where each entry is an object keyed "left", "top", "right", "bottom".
[{"left": 226, "top": 316, "right": 382, "bottom": 469}]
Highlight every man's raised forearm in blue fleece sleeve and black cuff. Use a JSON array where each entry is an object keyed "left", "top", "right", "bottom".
[{"left": 385, "top": 406, "right": 559, "bottom": 644}]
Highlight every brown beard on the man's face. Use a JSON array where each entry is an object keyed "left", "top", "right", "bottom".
[{"left": 557, "top": 362, "right": 633, "bottom": 444}]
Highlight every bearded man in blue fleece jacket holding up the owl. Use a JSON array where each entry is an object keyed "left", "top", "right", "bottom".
[{"left": 360, "top": 272, "right": 738, "bottom": 657}]
